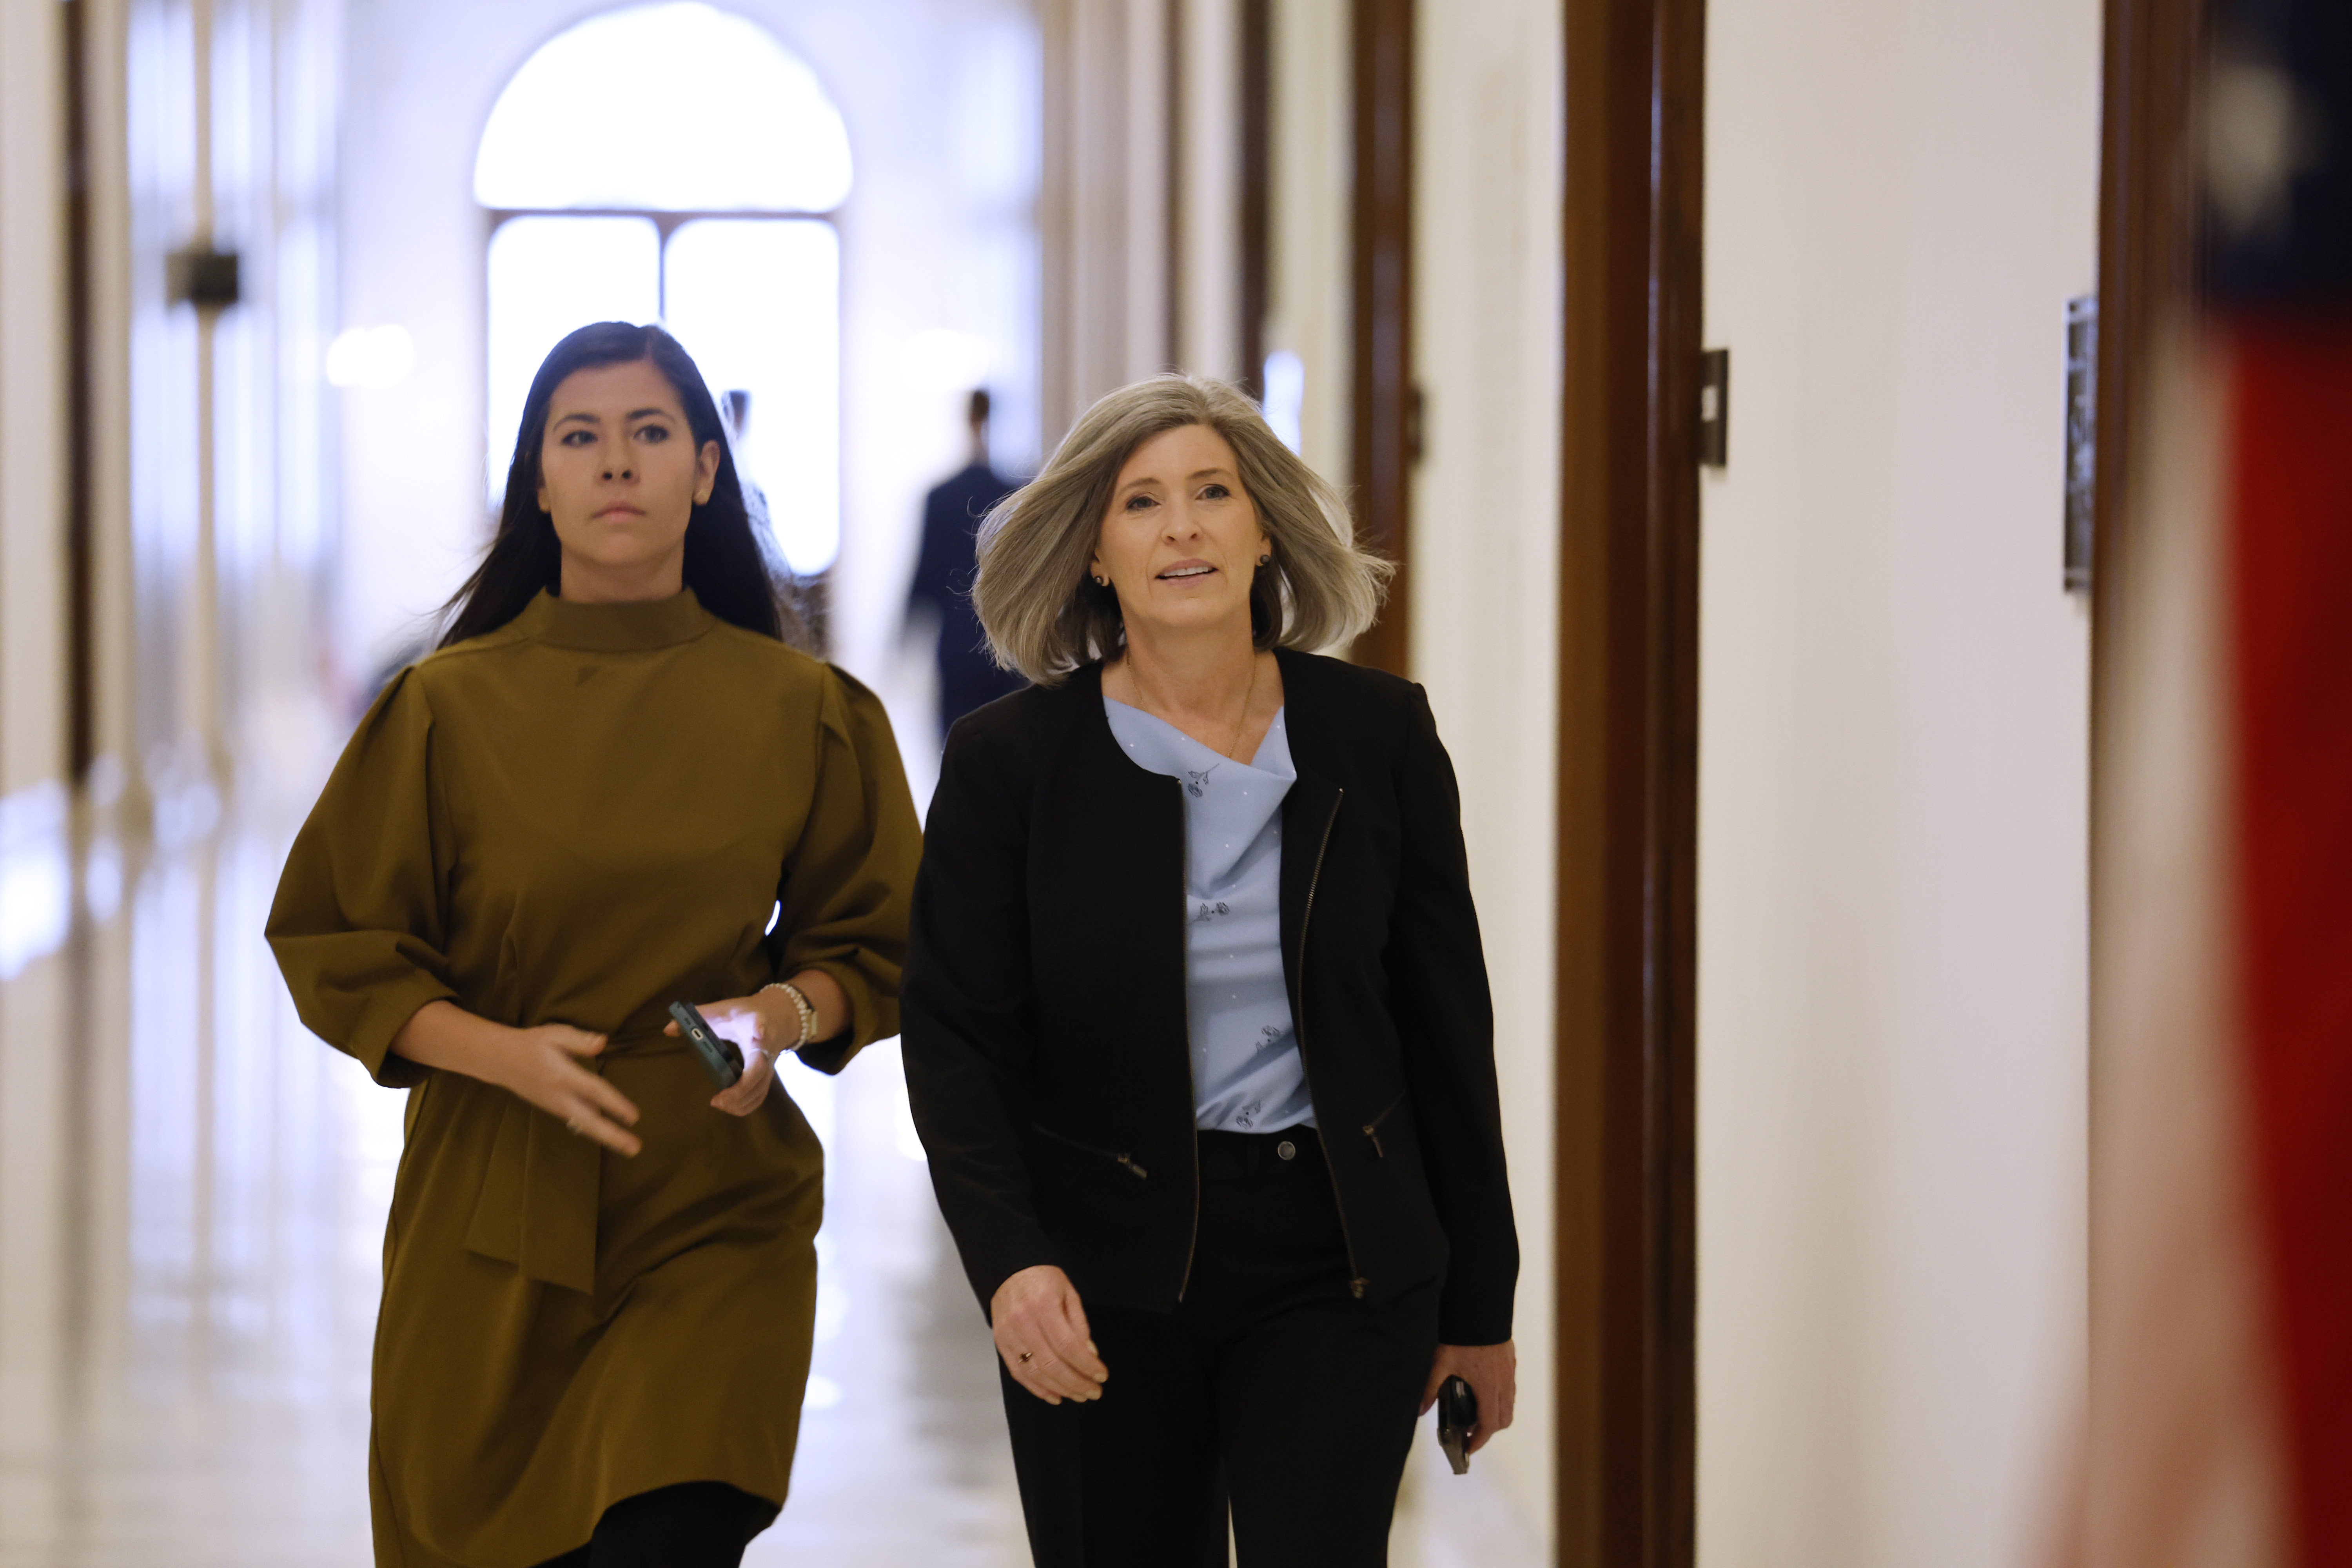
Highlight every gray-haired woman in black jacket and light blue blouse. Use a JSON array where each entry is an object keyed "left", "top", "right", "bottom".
[{"left": 901, "top": 376, "right": 1519, "bottom": 1568}]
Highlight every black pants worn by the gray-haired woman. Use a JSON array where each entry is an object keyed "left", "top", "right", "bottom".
[{"left": 1004, "top": 1129, "right": 1437, "bottom": 1568}]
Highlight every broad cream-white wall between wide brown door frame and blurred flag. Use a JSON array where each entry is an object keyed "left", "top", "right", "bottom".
[{"left": 1698, "top": 0, "right": 2100, "bottom": 1568}]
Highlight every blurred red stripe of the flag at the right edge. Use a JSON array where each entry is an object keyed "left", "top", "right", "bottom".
[{"left": 2220, "top": 315, "right": 2352, "bottom": 1566}]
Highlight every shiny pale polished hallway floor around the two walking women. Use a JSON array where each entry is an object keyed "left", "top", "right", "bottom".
[{"left": 0, "top": 792, "right": 1538, "bottom": 1568}]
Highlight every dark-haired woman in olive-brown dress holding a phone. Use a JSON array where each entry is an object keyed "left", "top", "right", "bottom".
[{"left": 268, "top": 322, "right": 920, "bottom": 1568}]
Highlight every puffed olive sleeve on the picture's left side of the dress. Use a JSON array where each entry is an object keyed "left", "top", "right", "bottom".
[{"left": 268, "top": 670, "right": 456, "bottom": 1089}]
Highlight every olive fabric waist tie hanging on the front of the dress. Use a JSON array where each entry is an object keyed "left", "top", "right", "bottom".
[{"left": 466, "top": 1025, "right": 687, "bottom": 1293}]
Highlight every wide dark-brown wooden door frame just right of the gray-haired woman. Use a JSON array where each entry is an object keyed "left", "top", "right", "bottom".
[{"left": 1552, "top": 0, "right": 1705, "bottom": 1568}]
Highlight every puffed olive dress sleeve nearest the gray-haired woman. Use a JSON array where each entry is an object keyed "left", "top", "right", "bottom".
[{"left": 776, "top": 670, "right": 922, "bottom": 1072}]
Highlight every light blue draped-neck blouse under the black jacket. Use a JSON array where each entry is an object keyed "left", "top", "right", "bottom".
[{"left": 1103, "top": 696, "right": 1315, "bottom": 1133}]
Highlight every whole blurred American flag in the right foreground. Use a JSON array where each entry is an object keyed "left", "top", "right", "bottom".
[{"left": 2063, "top": 0, "right": 2352, "bottom": 1568}]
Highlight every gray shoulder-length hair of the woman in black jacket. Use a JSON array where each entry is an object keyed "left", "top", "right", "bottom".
[{"left": 971, "top": 374, "right": 1397, "bottom": 686}]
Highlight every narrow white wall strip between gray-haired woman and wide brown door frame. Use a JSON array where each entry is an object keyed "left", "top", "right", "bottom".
[{"left": 1411, "top": 0, "right": 1564, "bottom": 1540}]
